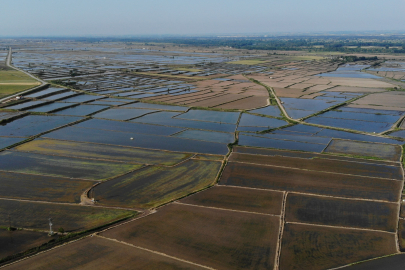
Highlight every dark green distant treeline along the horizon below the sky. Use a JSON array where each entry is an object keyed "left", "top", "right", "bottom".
[{"left": 38, "top": 35, "right": 405, "bottom": 53}]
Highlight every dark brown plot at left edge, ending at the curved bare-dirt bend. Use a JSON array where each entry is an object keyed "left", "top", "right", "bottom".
[{"left": 0, "top": 172, "right": 94, "bottom": 203}]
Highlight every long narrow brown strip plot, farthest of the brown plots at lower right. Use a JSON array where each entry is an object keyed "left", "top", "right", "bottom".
[{"left": 229, "top": 153, "right": 403, "bottom": 180}]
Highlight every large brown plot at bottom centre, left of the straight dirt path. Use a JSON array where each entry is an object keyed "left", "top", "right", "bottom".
[{"left": 102, "top": 204, "right": 280, "bottom": 269}]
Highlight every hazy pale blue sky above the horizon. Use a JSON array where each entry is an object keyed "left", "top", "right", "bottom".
[{"left": 0, "top": 0, "right": 405, "bottom": 36}]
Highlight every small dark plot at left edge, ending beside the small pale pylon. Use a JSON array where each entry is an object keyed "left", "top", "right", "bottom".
[{"left": 0, "top": 229, "right": 52, "bottom": 259}]
